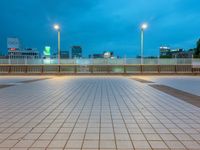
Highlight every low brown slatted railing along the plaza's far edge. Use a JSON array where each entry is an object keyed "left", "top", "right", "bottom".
[{"left": 0, "top": 65, "right": 200, "bottom": 74}]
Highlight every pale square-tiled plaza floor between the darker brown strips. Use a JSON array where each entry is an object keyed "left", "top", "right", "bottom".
[{"left": 0, "top": 77, "right": 200, "bottom": 150}]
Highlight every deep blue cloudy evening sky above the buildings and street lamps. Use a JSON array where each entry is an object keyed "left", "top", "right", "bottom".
[{"left": 0, "top": 0, "right": 200, "bottom": 57}]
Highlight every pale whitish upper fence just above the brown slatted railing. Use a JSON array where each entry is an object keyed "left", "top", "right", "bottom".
[{"left": 0, "top": 58, "right": 200, "bottom": 65}]
